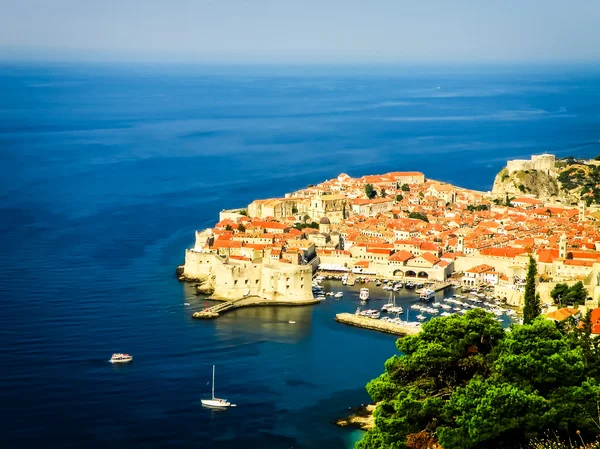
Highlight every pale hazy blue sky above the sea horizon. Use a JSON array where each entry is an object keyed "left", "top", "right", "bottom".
[{"left": 0, "top": 0, "right": 600, "bottom": 64}]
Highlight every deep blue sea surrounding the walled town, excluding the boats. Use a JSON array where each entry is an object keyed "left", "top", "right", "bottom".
[{"left": 0, "top": 64, "right": 600, "bottom": 449}]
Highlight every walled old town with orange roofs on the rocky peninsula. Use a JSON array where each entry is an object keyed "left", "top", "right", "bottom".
[{"left": 179, "top": 154, "right": 600, "bottom": 316}]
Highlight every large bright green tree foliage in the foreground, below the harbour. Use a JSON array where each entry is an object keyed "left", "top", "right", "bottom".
[{"left": 356, "top": 309, "right": 600, "bottom": 449}]
